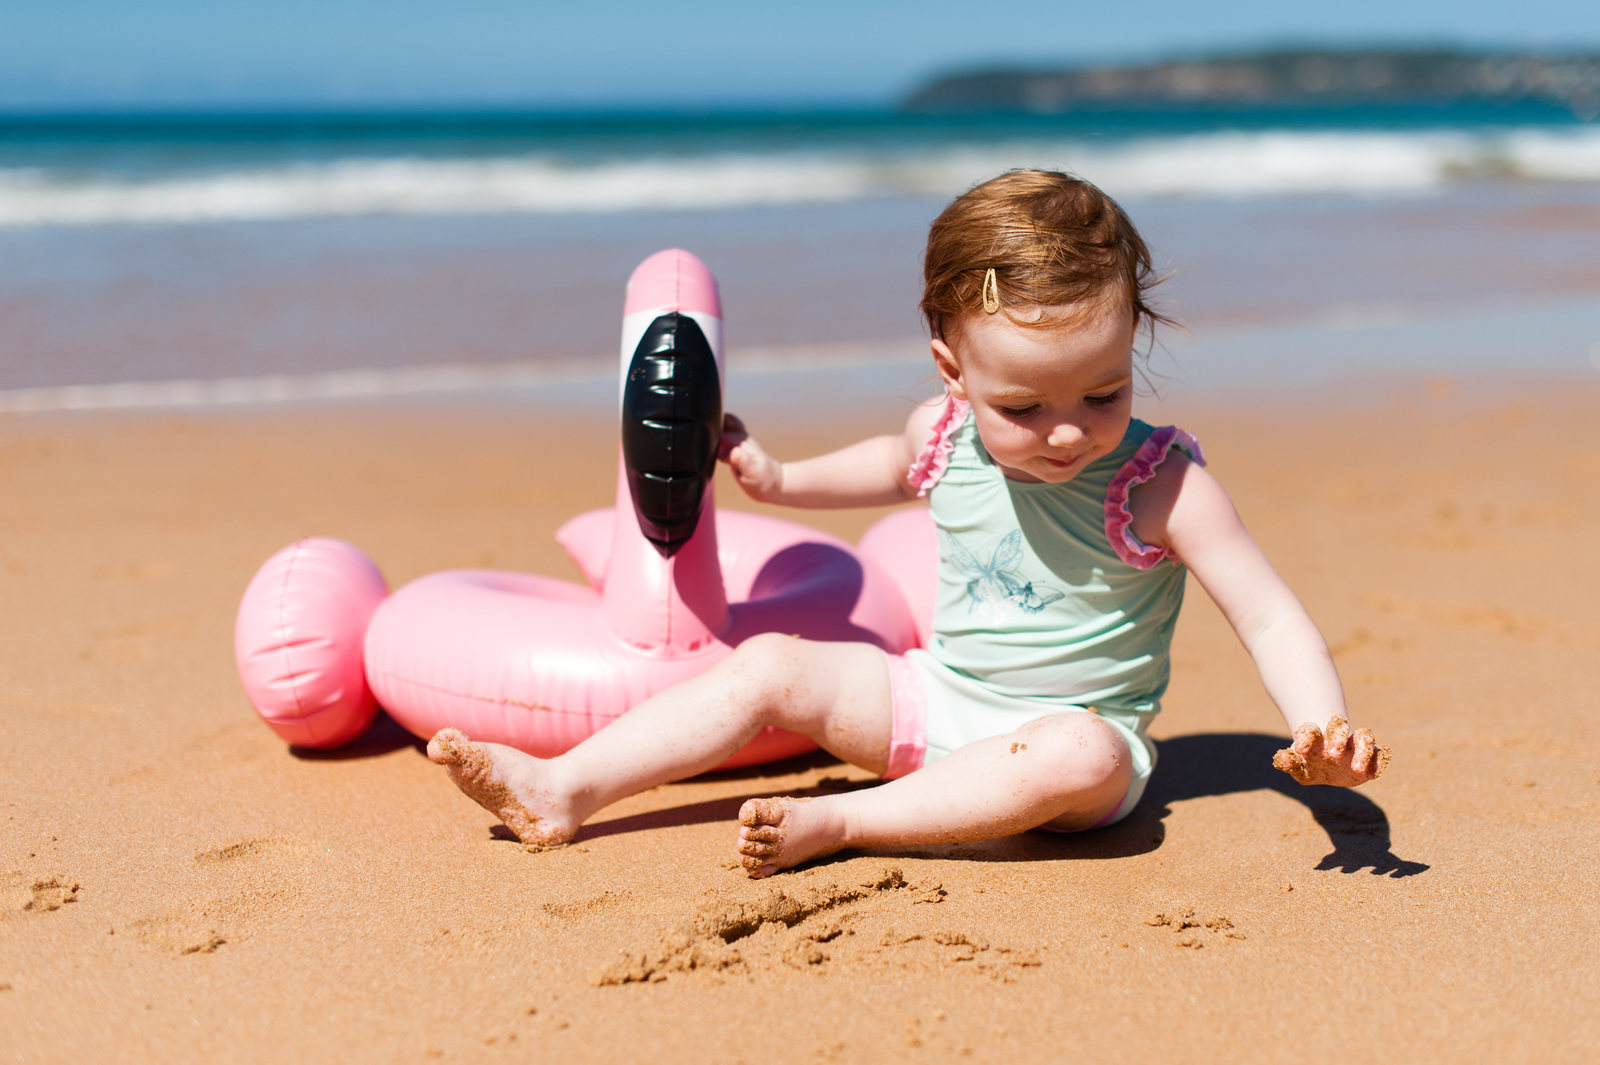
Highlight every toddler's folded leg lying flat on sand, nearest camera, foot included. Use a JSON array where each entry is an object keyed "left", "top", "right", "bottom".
[{"left": 739, "top": 712, "right": 1133, "bottom": 876}]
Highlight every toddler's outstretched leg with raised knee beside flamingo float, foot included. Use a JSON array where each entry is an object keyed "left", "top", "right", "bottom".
[{"left": 427, "top": 633, "right": 891, "bottom": 844}]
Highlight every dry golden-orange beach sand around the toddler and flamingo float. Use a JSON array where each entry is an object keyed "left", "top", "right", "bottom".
[{"left": 0, "top": 379, "right": 1600, "bottom": 1065}]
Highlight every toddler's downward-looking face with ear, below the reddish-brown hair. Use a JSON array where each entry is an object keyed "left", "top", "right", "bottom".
[{"left": 933, "top": 299, "right": 1133, "bottom": 485}]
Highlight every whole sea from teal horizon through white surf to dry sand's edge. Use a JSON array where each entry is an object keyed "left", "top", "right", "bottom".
[{"left": 0, "top": 104, "right": 1600, "bottom": 409}]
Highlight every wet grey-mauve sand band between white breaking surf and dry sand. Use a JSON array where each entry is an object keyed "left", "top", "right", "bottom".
[{"left": 0, "top": 184, "right": 1600, "bottom": 390}]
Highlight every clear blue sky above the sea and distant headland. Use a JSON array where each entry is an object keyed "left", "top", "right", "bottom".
[{"left": 0, "top": 0, "right": 1600, "bottom": 109}]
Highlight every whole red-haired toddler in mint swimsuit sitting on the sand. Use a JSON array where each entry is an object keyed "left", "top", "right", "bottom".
[{"left": 427, "top": 171, "right": 1389, "bottom": 876}]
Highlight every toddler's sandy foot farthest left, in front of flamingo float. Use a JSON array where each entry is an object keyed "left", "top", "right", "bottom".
[{"left": 427, "top": 729, "right": 581, "bottom": 848}]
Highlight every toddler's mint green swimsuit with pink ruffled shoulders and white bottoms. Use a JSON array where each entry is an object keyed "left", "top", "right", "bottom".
[{"left": 906, "top": 400, "right": 1203, "bottom": 824}]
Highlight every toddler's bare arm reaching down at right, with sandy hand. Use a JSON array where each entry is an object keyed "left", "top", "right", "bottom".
[{"left": 1130, "top": 451, "right": 1389, "bottom": 787}]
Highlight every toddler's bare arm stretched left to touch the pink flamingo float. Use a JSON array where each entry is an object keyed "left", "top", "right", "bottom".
[{"left": 717, "top": 403, "right": 941, "bottom": 509}]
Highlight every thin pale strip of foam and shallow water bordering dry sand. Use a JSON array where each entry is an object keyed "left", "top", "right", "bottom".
[{"left": 0, "top": 278, "right": 1600, "bottom": 417}]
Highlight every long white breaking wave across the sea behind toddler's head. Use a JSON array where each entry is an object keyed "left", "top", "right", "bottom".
[{"left": 0, "top": 126, "right": 1600, "bottom": 227}]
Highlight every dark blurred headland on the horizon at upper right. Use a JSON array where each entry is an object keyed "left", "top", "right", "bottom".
[{"left": 901, "top": 48, "right": 1600, "bottom": 120}]
